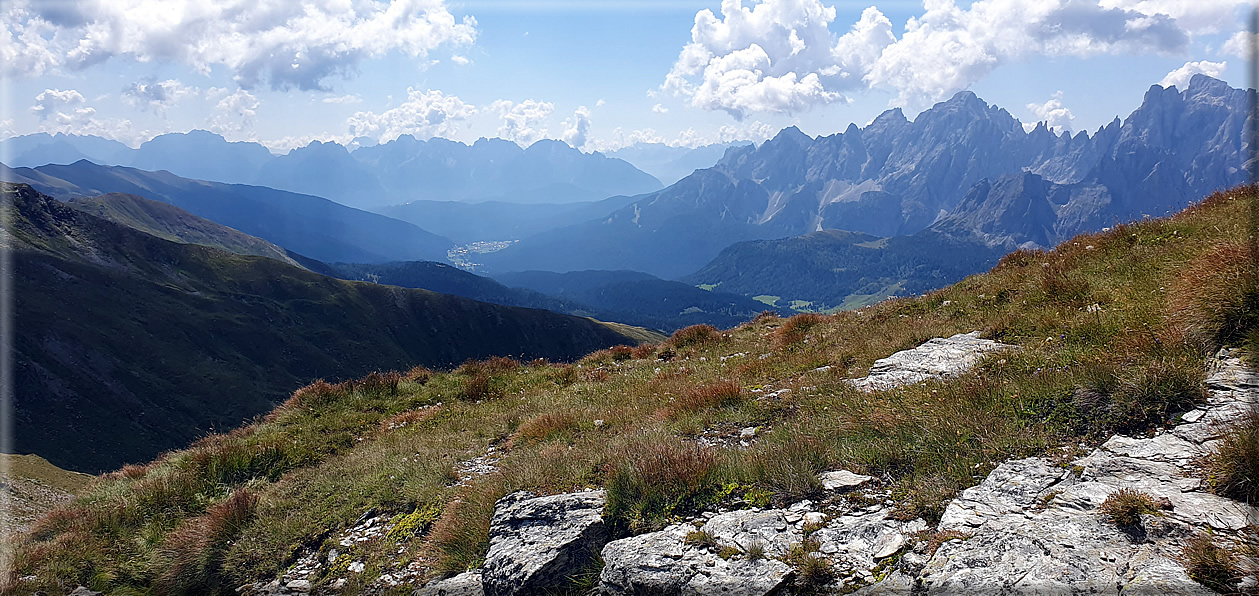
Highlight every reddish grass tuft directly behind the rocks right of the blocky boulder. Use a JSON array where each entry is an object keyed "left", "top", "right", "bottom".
[{"left": 603, "top": 441, "right": 718, "bottom": 536}]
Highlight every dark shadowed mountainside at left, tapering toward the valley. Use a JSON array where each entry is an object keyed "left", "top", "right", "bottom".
[{"left": 14, "top": 183, "right": 654, "bottom": 471}]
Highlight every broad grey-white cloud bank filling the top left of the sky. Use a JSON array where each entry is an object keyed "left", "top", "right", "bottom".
[{"left": 0, "top": 0, "right": 476, "bottom": 89}]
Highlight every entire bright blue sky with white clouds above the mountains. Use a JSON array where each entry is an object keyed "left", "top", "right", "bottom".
[{"left": 0, "top": 0, "right": 1246, "bottom": 151}]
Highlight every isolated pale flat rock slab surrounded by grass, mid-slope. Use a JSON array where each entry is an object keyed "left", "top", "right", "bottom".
[{"left": 849, "top": 331, "right": 1019, "bottom": 391}]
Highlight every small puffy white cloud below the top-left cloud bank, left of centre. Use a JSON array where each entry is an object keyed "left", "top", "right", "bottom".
[{"left": 346, "top": 87, "right": 476, "bottom": 142}]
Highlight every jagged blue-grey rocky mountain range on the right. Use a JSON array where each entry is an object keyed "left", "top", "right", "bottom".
[{"left": 486, "top": 76, "right": 1248, "bottom": 277}]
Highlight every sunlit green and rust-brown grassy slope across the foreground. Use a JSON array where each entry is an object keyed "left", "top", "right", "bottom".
[{"left": 10, "top": 187, "right": 1248, "bottom": 593}]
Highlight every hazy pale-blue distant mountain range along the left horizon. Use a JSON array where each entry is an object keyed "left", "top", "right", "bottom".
[{"left": 0, "top": 130, "right": 664, "bottom": 208}]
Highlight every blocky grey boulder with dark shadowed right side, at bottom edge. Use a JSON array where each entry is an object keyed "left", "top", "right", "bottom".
[{"left": 481, "top": 490, "right": 608, "bottom": 596}]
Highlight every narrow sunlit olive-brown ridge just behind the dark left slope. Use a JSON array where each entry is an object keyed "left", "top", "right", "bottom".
[{"left": 67, "top": 193, "right": 300, "bottom": 267}]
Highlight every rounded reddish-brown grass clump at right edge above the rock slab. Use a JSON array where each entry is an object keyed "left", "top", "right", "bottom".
[{"left": 1170, "top": 242, "right": 1259, "bottom": 349}]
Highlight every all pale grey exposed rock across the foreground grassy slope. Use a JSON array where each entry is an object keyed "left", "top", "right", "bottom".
[{"left": 234, "top": 334, "right": 1259, "bottom": 596}]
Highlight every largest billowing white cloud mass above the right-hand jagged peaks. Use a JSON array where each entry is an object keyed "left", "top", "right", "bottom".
[{"left": 658, "top": 0, "right": 1213, "bottom": 115}]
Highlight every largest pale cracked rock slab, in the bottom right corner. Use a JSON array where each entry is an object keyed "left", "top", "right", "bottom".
[{"left": 861, "top": 352, "right": 1259, "bottom": 596}]
